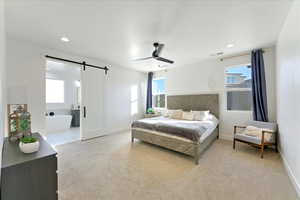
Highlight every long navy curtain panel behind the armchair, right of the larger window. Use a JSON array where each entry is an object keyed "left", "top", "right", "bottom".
[{"left": 251, "top": 49, "right": 268, "bottom": 122}]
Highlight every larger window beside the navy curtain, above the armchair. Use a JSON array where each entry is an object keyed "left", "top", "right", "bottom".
[{"left": 225, "top": 65, "right": 252, "bottom": 111}]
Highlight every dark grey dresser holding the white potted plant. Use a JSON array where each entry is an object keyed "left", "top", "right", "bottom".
[{"left": 1, "top": 133, "right": 58, "bottom": 200}]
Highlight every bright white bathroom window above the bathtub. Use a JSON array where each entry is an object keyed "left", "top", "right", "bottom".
[{"left": 46, "top": 79, "right": 65, "bottom": 103}]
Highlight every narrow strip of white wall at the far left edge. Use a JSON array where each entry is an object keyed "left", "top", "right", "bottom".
[{"left": 0, "top": 0, "right": 5, "bottom": 177}]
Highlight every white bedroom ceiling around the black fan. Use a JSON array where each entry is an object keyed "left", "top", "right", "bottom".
[{"left": 6, "top": 0, "right": 291, "bottom": 71}]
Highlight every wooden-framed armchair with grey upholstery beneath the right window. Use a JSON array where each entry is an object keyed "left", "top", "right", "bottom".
[{"left": 233, "top": 121, "right": 278, "bottom": 158}]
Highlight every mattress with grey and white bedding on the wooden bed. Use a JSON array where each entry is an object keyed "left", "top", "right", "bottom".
[{"left": 132, "top": 115, "right": 218, "bottom": 143}]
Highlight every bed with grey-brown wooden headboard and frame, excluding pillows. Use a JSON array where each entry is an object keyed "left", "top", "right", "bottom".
[{"left": 131, "top": 94, "right": 219, "bottom": 164}]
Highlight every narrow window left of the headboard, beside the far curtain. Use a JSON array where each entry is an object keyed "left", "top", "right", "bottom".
[{"left": 152, "top": 78, "right": 166, "bottom": 108}]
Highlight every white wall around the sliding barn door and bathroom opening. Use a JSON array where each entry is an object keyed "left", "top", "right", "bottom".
[{"left": 7, "top": 38, "right": 146, "bottom": 137}]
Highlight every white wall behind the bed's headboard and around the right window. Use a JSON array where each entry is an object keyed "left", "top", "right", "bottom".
[{"left": 160, "top": 48, "right": 276, "bottom": 139}]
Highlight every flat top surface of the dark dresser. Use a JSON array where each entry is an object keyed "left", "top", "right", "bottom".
[{"left": 2, "top": 133, "right": 57, "bottom": 168}]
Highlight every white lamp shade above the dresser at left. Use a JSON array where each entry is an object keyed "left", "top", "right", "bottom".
[{"left": 7, "top": 86, "right": 28, "bottom": 104}]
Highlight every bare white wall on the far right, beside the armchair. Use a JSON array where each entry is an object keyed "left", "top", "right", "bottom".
[{"left": 277, "top": 1, "right": 300, "bottom": 196}]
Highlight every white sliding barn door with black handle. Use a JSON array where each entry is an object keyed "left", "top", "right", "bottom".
[{"left": 80, "top": 67, "right": 105, "bottom": 140}]
